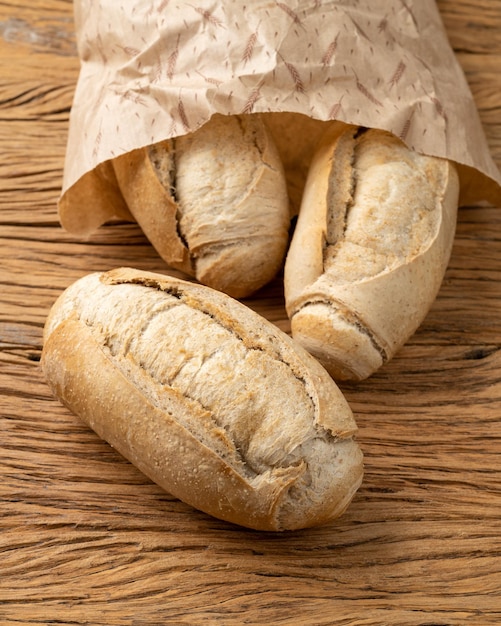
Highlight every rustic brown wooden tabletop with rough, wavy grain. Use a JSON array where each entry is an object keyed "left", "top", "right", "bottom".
[{"left": 0, "top": 0, "right": 501, "bottom": 626}]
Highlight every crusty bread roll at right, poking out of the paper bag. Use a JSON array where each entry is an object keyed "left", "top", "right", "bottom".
[{"left": 284, "top": 123, "right": 459, "bottom": 380}]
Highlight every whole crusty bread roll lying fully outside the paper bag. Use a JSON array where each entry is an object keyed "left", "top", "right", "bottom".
[{"left": 42, "top": 268, "right": 362, "bottom": 531}]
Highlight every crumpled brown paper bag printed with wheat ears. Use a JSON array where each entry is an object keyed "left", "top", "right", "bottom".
[{"left": 60, "top": 0, "right": 501, "bottom": 233}]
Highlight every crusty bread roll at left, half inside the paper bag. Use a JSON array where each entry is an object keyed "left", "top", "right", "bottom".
[{"left": 113, "top": 115, "right": 290, "bottom": 298}]
